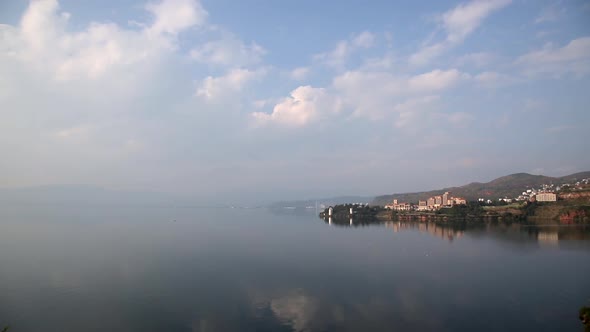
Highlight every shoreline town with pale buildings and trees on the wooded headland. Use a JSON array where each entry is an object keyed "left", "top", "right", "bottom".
[{"left": 320, "top": 178, "right": 590, "bottom": 224}]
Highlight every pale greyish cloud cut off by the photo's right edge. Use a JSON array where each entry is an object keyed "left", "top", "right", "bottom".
[{"left": 515, "top": 37, "right": 590, "bottom": 76}]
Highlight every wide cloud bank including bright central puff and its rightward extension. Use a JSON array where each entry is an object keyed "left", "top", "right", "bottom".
[{"left": 252, "top": 69, "right": 469, "bottom": 128}]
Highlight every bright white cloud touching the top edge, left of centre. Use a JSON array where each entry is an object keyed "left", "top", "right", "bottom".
[{"left": 146, "top": 0, "right": 208, "bottom": 35}]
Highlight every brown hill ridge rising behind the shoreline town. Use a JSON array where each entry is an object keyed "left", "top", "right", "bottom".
[{"left": 372, "top": 171, "right": 590, "bottom": 205}]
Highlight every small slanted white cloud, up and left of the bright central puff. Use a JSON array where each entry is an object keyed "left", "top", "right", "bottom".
[{"left": 196, "top": 68, "right": 266, "bottom": 101}]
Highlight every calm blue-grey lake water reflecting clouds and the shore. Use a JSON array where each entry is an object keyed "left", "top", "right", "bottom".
[{"left": 0, "top": 206, "right": 590, "bottom": 332}]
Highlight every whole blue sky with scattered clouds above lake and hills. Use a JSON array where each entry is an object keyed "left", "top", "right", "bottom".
[{"left": 0, "top": 0, "right": 590, "bottom": 202}]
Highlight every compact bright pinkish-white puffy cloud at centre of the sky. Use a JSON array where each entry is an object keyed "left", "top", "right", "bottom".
[{"left": 252, "top": 86, "right": 342, "bottom": 127}]
